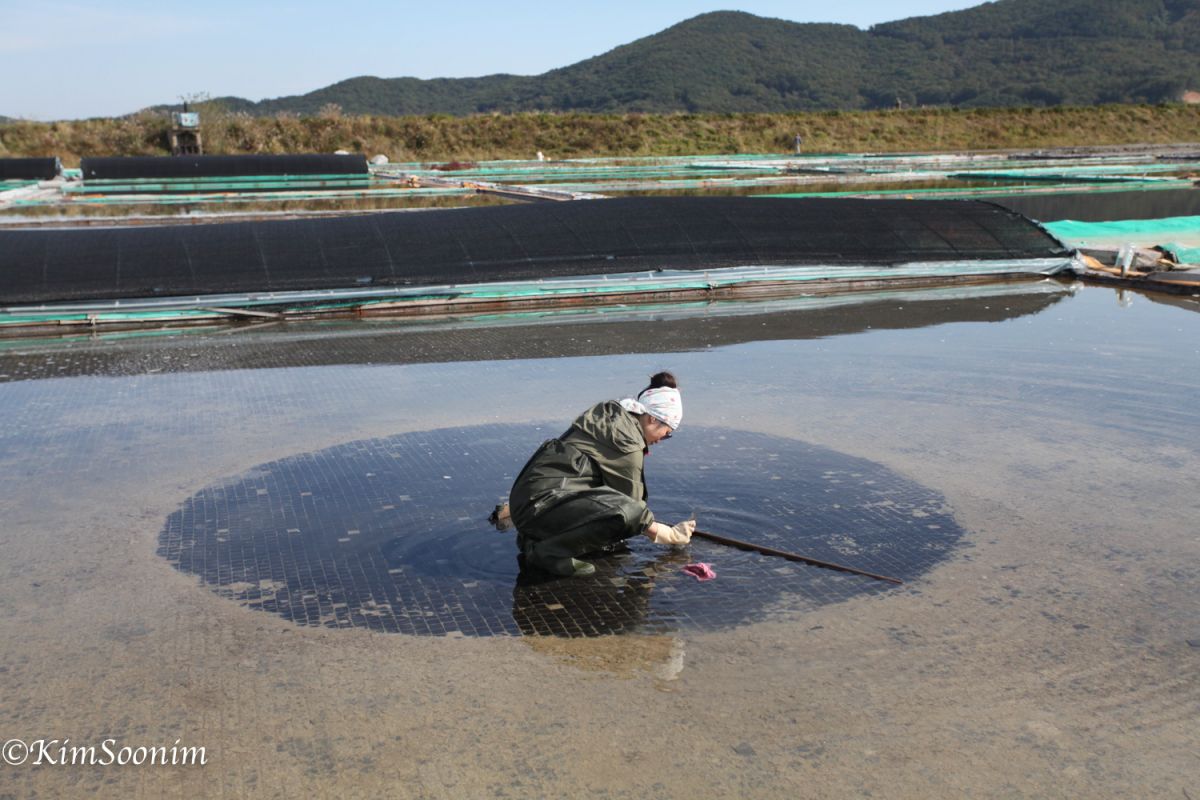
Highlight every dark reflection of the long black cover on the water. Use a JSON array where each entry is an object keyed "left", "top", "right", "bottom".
[{"left": 0, "top": 281, "right": 1070, "bottom": 383}]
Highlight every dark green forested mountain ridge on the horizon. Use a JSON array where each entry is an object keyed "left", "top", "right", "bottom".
[{"left": 182, "top": 0, "right": 1200, "bottom": 115}]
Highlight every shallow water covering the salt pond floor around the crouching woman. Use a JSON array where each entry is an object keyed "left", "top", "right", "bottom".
[{"left": 0, "top": 282, "right": 1200, "bottom": 798}]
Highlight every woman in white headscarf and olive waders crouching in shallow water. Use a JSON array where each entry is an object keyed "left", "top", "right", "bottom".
[{"left": 509, "top": 372, "right": 696, "bottom": 576}]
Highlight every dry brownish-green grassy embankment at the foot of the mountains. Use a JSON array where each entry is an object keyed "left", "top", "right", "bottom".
[{"left": 0, "top": 103, "right": 1200, "bottom": 167}]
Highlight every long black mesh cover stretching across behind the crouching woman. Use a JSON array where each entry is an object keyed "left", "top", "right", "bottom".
[{"left": 0, "top": 197, "right": 1063, "bottom": 305}]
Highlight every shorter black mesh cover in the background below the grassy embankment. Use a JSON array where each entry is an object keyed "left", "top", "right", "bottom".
[{"left": 80, "top": 154, "right": 368, "bottom": 181}]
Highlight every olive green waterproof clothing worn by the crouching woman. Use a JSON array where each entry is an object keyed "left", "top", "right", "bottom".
[{"left": 509, "top": 401, "right": 654, "bottom": 567}]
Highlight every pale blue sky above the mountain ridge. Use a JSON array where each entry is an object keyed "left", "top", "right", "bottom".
[{"left": 0, "top": 0, "right": 979, "bottom": 120}]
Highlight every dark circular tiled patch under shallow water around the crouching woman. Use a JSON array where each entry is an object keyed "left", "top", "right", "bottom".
[{"left": 158, "top": 425, "right": 962, "bottom": 636}]
